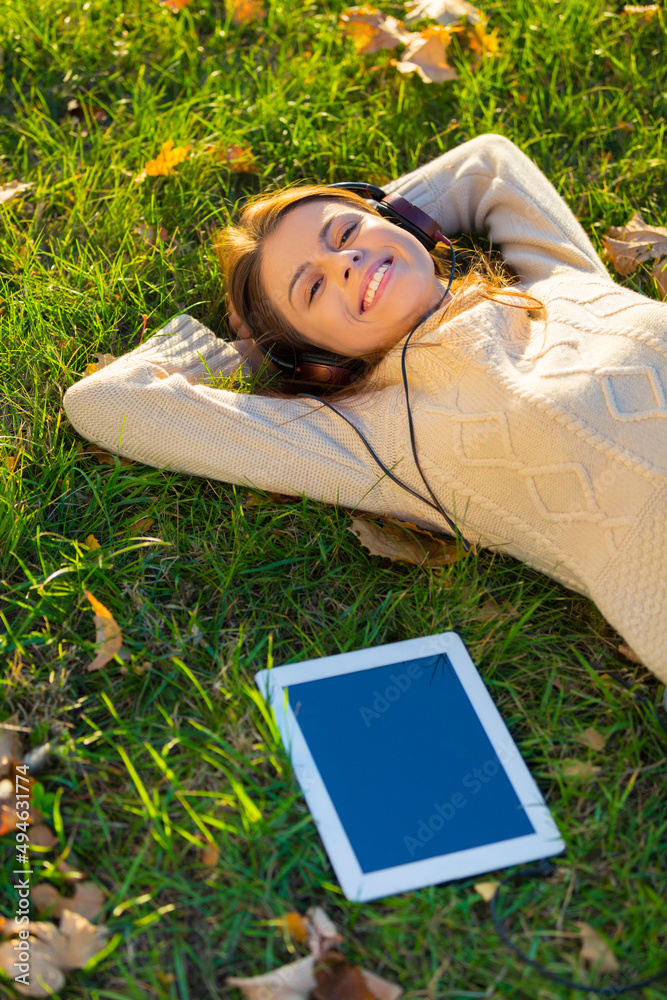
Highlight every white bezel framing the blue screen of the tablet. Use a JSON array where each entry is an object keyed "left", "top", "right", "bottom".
[{"left": 255, "top": 632, "right": 565, "bottom": 903}]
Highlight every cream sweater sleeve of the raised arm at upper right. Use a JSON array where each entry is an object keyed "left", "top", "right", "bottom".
[{"left": 386, "top": 135, "right": 611, "bottom": 284}]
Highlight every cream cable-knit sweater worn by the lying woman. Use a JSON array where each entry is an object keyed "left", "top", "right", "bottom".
[{"left": 64, "top": 135, "right": 667, "bottom": 682}]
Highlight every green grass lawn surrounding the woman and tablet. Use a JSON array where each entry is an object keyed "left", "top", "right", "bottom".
[{"left": 0, "top": 0, "right": 667, "bottom": 1000}]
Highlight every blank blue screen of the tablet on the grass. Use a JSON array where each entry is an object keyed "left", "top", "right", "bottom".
[{"left": 288, "top": 654, "right": 535, "bottom": 874}]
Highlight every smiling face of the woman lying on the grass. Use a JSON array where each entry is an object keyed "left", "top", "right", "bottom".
[{"left": 260, "top": 198, "right": 443, "bottom": 357}]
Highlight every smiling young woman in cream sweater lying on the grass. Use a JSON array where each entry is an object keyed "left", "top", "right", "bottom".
[{"left": 64, "top": 135, "right": 667, "bottom": 682}]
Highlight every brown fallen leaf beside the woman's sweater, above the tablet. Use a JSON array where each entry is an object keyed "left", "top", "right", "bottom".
[{"left": 349, "top": 517, "right": 461, "bottom": 566}]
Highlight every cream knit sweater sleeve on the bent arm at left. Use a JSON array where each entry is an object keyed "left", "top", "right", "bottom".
[{"left": 63, "top": 316, "right": 393, "bottom": 511}]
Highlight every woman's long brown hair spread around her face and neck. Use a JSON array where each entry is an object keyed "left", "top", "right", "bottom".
[{"left": 215, "top": 185, "right": 536, "bottom": 398}]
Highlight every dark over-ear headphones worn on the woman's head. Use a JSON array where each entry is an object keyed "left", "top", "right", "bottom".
[{"left": 258, "top": 181, "right": 454, "bottom": 386}]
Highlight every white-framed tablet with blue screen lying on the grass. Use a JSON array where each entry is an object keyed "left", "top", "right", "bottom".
[{"left": 255, "top": 632, "right": 565, "bottom": 902}]
